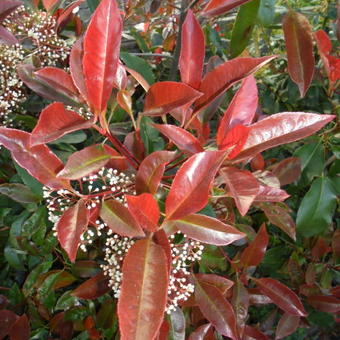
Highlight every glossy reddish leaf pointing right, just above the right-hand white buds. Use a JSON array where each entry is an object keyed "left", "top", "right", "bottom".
[{"left": 163, "top": 214, "right": 246, "bottom": 246}]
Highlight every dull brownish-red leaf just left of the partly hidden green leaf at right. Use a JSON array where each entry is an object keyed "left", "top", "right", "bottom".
[{"left": 271, "top": 157, "right": 301, "bottom": 185}]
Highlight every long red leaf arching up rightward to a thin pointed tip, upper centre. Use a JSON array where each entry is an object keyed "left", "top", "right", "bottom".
[{"left": 194, "top": 56, "right": 276, "bottom": 111}]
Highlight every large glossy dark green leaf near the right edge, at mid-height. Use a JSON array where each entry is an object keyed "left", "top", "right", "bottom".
[{"left": 296, "top": 177, "right": 336, "bottom": 237}]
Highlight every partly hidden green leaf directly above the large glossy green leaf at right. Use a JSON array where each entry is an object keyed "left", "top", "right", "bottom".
[{"left": 294, "top": 141, "right": 325, "bottom": 181}]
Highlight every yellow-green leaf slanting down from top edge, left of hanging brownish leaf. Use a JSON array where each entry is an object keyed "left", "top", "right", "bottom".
[{"left": 230, "top": 0, "right": 260, "bottom": 58}]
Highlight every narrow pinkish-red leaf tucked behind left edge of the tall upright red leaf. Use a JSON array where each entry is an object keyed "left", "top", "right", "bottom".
[{"left": 70, "top": 38, "right": 88, "bottom": 102}]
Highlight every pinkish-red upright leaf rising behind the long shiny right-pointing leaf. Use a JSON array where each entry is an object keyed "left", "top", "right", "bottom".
[{"left": 216, "top": 75, "right": 258, "bottom": 145}]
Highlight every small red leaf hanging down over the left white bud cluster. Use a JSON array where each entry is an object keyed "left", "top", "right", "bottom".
[{"left": 56, "top": 199, "right": 89, "bottom": 262}]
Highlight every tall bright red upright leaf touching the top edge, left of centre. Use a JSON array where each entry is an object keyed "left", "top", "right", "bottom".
[{"left": 83, "top": 0, "right": 123, "bottom": 114}]
